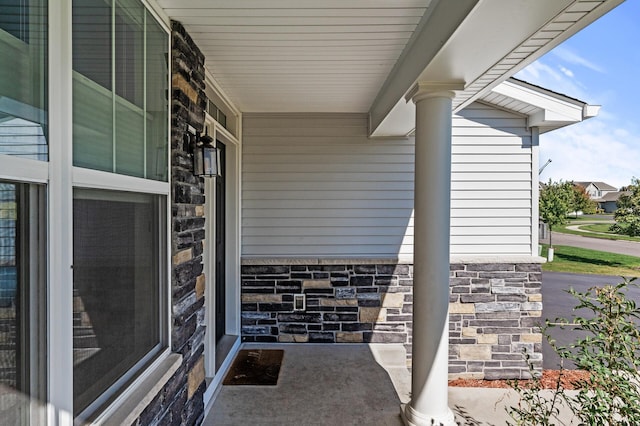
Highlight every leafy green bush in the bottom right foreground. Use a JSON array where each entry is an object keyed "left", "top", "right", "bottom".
[{"left": 507, "top": 280, "right": 640, "bottom": 426}]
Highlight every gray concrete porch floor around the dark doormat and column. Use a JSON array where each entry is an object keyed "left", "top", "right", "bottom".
[{"left": 203, "top": 344, "right": 570, "bottom": 426}]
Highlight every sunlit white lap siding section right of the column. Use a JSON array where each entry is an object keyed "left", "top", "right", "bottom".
[{"left": 451, "top": 103, "right": 536, "bottom": 255}]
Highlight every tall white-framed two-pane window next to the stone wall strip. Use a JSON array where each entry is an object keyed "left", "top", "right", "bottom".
[{"left": 71, "top": 0, "right": 170, "bottom": 422}]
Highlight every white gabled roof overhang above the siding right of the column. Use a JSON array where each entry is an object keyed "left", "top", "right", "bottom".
[{"left": 478, "top": 78, "right": 600, "bottom": 133}]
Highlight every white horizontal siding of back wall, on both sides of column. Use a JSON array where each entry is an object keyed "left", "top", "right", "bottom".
[{"left": 242, "top": 103, "right": 534, "bottom": 260}]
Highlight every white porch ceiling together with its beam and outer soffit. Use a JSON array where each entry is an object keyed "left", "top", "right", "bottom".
[{"left": 157, "top": 0, "right": 623, "bottom": 136}]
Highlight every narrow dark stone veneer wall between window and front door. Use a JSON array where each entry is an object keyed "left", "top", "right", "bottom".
[{"left": 136, "top": 22, "right": 206, "bottom": 426}]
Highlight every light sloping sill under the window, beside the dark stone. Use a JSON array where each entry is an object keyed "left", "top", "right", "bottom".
[{"left": 96, "top": 353, "right": 182, "bottom": 425}]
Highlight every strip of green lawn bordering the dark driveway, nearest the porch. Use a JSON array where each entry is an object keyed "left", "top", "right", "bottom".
[{"left": 542, "top": 244, "right": 640, "bottom": 277}]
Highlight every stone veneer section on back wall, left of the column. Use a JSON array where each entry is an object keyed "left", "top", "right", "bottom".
[{"left": 242, "top": 264, "right": 413, "bottom": 343}]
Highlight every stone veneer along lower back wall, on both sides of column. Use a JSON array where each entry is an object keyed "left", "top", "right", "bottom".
[{"left": 242, "top": 260, "right": 542, "bottom": 379}]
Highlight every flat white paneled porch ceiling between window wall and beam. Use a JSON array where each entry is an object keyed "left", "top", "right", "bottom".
[{"left": 158, "top": 0, "right": 431, "bottom": 112}]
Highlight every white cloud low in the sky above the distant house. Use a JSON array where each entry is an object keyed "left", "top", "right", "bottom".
[{"left": 540, "top": 117, "right": 640, "bottom": 187}]
